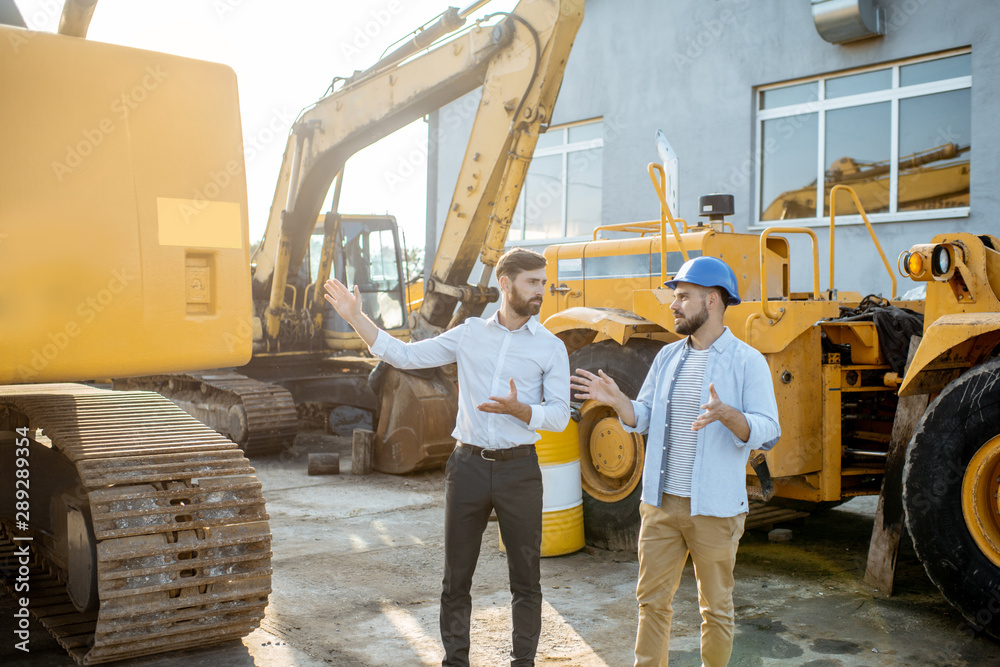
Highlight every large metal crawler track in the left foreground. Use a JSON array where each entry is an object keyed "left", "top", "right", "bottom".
[{"left": 0, "top": 385, "right": 271, "bottom": 664}]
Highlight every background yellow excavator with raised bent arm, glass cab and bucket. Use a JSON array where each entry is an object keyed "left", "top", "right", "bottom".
[{"left": 125, "top": 0, "right": 583, "bottom": 473}]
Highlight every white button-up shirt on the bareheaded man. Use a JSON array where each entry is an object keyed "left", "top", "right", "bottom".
[{"left": 371, "top": 313, "right": 569, "bottom": 449}]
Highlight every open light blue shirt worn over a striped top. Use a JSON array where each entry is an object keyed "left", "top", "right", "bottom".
[{"left": 623, "top": 327, "right": 781, "bottom": 517}]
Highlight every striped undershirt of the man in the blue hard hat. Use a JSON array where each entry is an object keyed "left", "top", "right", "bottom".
[{"left": 663, "top": 343, "right": 709, "bottom": 498}]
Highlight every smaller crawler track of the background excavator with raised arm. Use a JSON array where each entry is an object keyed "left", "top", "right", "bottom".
[{"left": 115, "top": 370, "right": 298, "bottom": 457}]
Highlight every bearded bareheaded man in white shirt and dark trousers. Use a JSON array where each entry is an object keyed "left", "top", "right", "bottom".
[{"left": 325, "top": 248, "right": 569, "bottom": 667}]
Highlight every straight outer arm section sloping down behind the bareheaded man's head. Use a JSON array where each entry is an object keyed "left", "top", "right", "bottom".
[{"left": 413, "top": 0, "right": 583, "bottom": 338}]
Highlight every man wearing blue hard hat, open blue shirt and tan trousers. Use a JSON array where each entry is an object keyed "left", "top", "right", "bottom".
[{"left": 571, "top": 256, "right": 781, "bottom": 667}]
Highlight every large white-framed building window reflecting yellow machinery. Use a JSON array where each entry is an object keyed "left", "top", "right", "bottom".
[{"left": 756, "top": 50, "right": 972, "bottom": 225}]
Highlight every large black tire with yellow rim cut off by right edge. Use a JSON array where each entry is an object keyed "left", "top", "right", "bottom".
[{"left": 903, "top": 359, "right": 1000, "bottom": 638}]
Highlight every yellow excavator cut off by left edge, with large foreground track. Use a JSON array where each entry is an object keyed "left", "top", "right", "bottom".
[{"left": 0, "top": 0, "right": 271, "bottom": 664}]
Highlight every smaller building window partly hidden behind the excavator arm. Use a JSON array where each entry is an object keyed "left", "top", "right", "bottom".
[{"left": 508, "top": 121, "right": 604, "bottom": 241}]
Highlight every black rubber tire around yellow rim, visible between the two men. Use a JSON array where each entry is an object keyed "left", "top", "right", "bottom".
[{"left": 569, "top": 339, "right": 663, "bottom": 551}]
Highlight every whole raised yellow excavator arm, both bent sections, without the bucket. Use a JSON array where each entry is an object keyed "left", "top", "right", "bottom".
[{"left": 253, "top": 0, "right": 583, "bottom": 340}]
